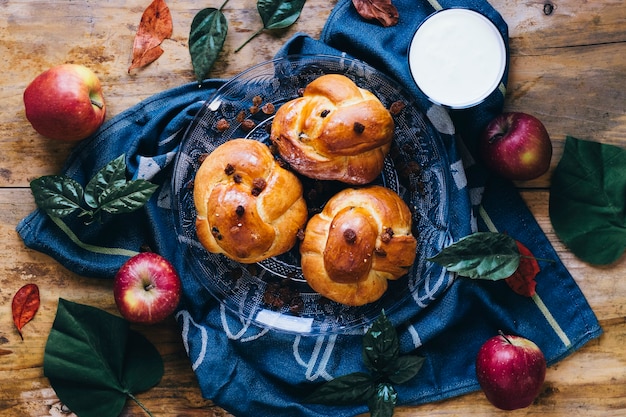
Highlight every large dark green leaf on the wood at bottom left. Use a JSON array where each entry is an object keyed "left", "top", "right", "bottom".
[{"left": 44, "top": 299, "right": 163, "bottom": 417}]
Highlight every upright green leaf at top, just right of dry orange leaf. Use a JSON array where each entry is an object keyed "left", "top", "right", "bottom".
[{"left": 189, "top": 3, "right": 228, "bottom": 82}]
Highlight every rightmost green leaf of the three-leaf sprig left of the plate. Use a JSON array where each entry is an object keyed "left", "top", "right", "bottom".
[{"left": 99, "top": 180, "right": 158, "bottom": 214}]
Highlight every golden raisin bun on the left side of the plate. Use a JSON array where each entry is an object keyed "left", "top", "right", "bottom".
[{"left": 194, "top": 139, "right": 308, "bottom": 263}]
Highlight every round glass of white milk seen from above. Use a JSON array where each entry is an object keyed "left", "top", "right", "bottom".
[{"left": 408, "top": 8, "right": 507, "bottom": 109}]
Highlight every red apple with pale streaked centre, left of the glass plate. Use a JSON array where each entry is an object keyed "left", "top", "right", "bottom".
[{"left": 113, "top": 252, "right": 182, "bottom": 324}]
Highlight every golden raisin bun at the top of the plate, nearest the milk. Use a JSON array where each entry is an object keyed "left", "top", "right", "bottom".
[{"left": 271, "top": 74, "right": 394, "bottom": 184}]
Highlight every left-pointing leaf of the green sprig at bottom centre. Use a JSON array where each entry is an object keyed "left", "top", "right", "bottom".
[{"left": 304, "top": 372, "right": 375, "bottom": 405}]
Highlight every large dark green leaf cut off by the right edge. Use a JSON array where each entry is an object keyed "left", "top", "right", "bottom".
[{"left": 549, "top": 136, "right": 626, "bottom": 265}]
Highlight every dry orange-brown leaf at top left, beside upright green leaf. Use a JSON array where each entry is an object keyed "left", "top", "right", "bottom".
[{"left": 128, "top": 0, "right": 174, "bottom": 73}]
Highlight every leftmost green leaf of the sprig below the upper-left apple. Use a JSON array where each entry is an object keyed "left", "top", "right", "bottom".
[{"left": 30, "top": 175, "right": 84, "bottom": 217}]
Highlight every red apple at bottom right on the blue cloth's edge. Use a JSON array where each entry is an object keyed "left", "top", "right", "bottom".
[{"left": 476, "top": 333, "right": 546, "bottom": 410}]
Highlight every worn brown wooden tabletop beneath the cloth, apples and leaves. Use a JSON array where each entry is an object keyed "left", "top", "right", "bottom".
[{"left": 0, "top": 0, "right": 626, "bottom": 417}]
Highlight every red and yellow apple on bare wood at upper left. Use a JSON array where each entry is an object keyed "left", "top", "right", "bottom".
[{"left": 24, "top": 64, "right": 106, "bottom": 141}]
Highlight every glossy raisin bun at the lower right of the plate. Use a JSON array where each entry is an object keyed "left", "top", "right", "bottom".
[{"left": 300, "top": 185, "right": 417, "bottom": 306}]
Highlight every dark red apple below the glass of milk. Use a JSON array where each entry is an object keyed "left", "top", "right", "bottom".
[{"left": 479, "top": 112, "right": 552, "bottom": 181}]
